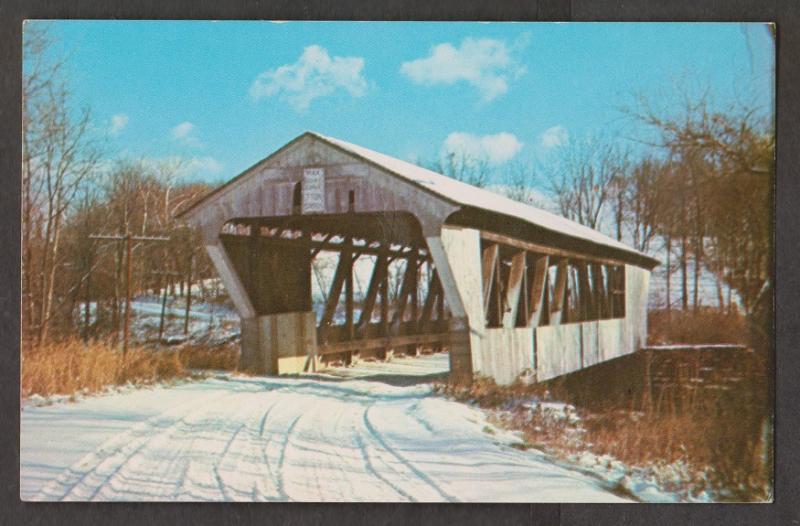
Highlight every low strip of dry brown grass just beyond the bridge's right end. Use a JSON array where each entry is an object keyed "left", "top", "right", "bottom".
[{"left": 647, "top": 307, "right": 750, "bottom": 345}]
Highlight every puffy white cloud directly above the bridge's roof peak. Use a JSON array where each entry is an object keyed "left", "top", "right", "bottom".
[{"left": 250, "top": 45, "right": 367, "bottom": 112}]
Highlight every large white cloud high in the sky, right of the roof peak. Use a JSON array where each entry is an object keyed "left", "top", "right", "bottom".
[{"left": 400, "top": 38, "right": 525, "bottom": 102}]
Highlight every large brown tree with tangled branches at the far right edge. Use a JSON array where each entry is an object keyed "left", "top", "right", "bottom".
[{"left": 625, "top": 91, "right": 775, "bottom": 312}]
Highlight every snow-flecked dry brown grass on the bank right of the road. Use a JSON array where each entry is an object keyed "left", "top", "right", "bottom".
[{"left": 442, "top": 378, "right": 772, "bottom": 501}]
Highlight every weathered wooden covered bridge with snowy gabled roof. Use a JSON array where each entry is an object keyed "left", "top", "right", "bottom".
[{"left": 181, "top": 132, "right": 657, "bottom": 384}]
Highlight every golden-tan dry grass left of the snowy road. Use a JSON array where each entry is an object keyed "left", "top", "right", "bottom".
[{"left": 20, "top": 339, "right": 187, "bottom": 398}]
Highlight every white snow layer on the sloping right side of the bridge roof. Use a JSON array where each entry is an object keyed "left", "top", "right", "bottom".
[{"left": 307, "top": 132, "right": 652, "bottom": 259}]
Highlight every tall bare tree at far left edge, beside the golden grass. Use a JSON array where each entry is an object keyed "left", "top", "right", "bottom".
[{"left": 22, "top": 26, "right": 99, "bottom": 342}]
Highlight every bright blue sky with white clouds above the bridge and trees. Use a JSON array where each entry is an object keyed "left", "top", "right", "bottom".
[{"left": 29, "top": 21, "right": 774, "bottom": 188}]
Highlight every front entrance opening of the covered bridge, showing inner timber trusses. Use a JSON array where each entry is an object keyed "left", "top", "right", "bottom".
[{"left": 219, "top": 212, "right": 451, "bottom": 380}]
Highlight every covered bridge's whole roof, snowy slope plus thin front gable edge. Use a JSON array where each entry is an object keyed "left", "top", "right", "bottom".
[{"left": 180, "top": 131, "right": 659, "bottom": 268}]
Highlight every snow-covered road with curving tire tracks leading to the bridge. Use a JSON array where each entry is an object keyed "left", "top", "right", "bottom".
[{"left": 21, "top": 356, "right": 623, "bottom": 502}]
